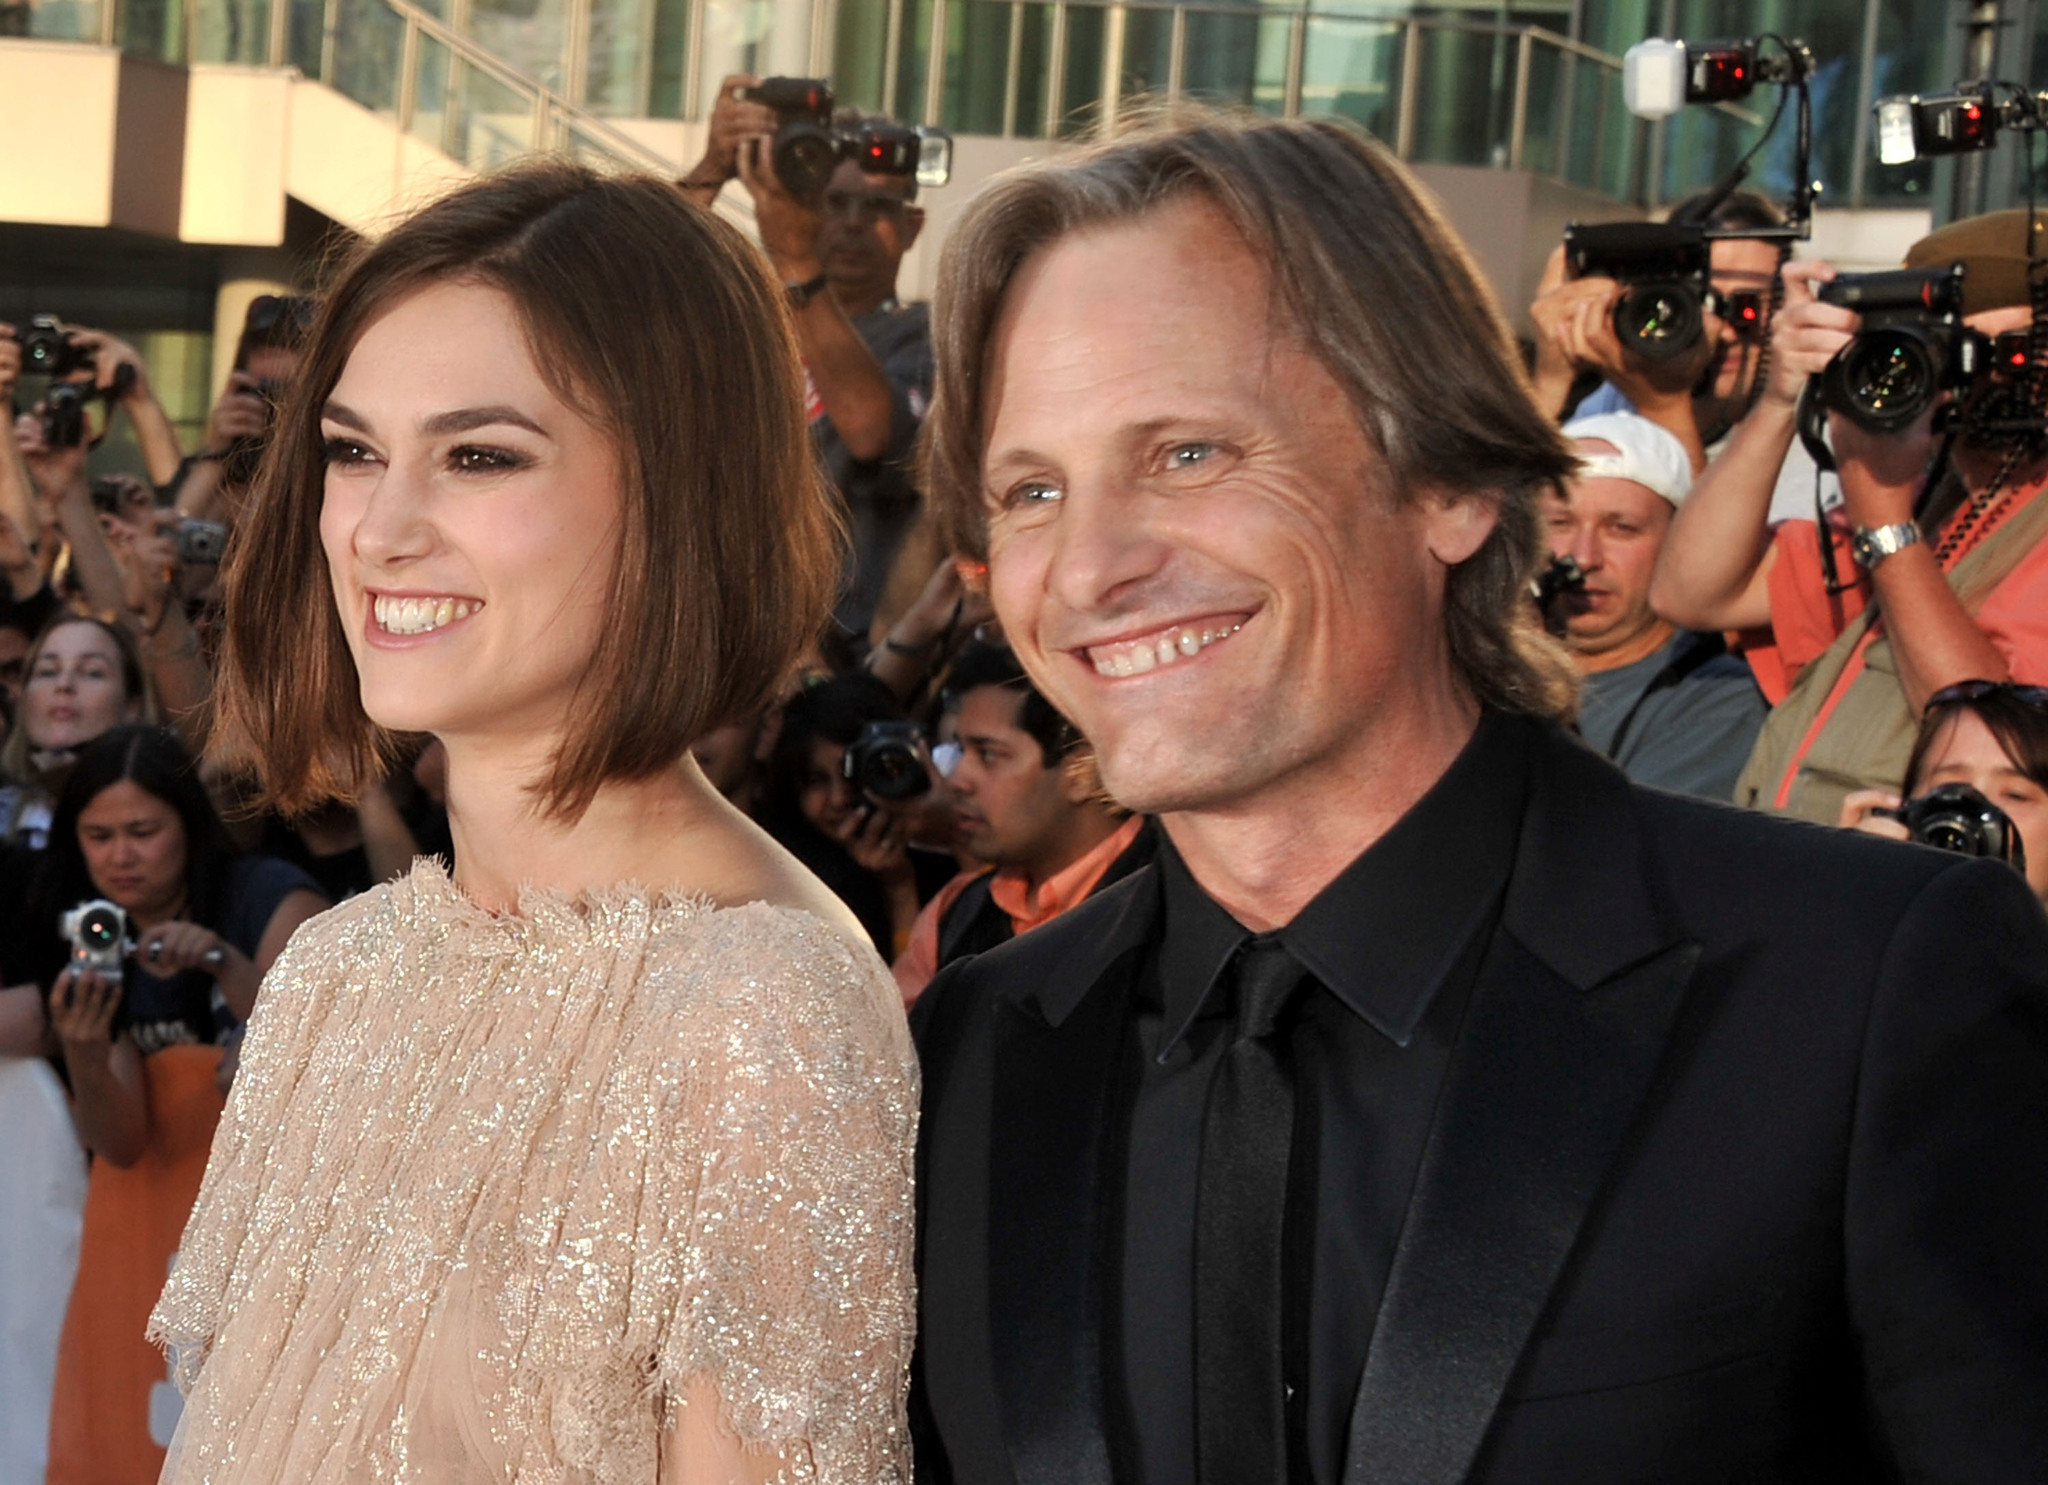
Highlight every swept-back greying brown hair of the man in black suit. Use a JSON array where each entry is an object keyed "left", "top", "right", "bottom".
[{"left": 924, "top": 107, "right": 1577, "bottom": 717}]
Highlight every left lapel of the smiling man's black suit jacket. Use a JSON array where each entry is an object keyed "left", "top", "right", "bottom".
[{"left": 989, "top": 879, "right": 1157, "bottom": 1485}]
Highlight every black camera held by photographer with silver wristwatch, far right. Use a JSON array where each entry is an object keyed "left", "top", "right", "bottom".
[{"left": 1815, "top": 264, "right": 1989, "bottom": 432}]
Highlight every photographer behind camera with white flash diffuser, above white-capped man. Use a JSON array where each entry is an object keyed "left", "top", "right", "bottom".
[{"left": 1530, "top": 190, "right": 1782, "bottom": 473}]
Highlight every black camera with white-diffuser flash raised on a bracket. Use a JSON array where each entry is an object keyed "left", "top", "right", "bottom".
[{"left": 1565, "top": 37, "right": 1812, "bottom": 360}]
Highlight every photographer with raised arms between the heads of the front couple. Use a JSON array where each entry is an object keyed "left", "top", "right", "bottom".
[{"left": 682, "top": 76, "right": 932, "bottom": 641}]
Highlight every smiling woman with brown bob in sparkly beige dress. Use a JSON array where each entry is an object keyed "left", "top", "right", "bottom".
[{"left": 152, "top": 162, "right": 915, "bottom": 1485}]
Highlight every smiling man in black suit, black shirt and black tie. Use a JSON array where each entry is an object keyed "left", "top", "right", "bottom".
[{"left": 913, "top": 117, "right": 2048, "bottom": 1485}]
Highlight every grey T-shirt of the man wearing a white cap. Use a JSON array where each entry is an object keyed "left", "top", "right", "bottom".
[{"left": 1579, "top": 629, "right": 1769, "bottom": 801}]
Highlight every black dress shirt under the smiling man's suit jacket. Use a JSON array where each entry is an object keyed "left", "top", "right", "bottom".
[{"left": 1106, "top": 715, "right": 1528, "bottom": 1485}]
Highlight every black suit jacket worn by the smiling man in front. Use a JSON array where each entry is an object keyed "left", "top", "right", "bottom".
[{"left": 913, "top": 723, "right": 2048, "bottom": 1485}]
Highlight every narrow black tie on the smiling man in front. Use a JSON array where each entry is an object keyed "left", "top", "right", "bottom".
[{"left": 1194, "top": 938, "right": 1305, "bottom": 1485}]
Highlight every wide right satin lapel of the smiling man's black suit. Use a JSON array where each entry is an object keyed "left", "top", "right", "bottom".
[{"left": 1346, "top": 737, "right": 1700, "bottom": 1485}]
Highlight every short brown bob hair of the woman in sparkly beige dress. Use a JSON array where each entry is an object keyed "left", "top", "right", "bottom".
[{"left": 213, "top": 162, "right": 844, "bottom": 819}]
